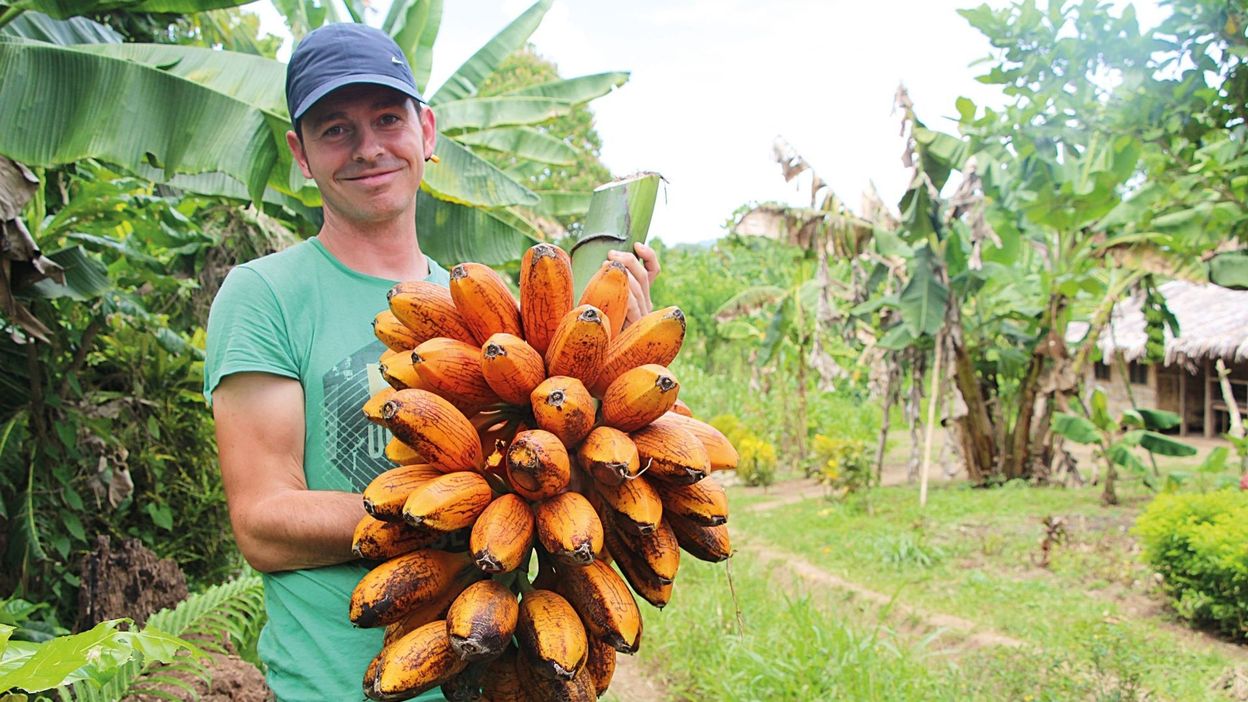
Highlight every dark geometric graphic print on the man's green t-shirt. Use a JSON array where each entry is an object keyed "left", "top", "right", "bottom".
[{"left": 321, "top": 341, "right": 393, "bottom": 491}]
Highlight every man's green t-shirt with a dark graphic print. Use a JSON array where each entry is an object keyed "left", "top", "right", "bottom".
[{"left": 203, "top": 239, "right": 449, "bottom": 702}]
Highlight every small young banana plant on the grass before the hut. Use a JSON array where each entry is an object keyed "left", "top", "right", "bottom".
[{"left": 1052, "top": 387, "right": 1198, "bottom": 505}]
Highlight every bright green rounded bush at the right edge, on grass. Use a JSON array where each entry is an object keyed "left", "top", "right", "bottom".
[{"left": 1134, "top": 490, "right": 1248, "bottom": 640}]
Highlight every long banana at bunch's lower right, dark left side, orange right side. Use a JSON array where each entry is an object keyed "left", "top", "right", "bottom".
[{"left": 555, "top": 561, "right": 641, "bottom": 653}]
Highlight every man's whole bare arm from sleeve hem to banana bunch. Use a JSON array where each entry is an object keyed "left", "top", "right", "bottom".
[{"left": 212, "top": 373, "right": 364, "bottom": 572}]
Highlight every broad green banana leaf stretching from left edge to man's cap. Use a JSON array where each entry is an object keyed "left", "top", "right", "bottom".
[{"left": 0, "top": 39, "right": 280, "bottom": 200}]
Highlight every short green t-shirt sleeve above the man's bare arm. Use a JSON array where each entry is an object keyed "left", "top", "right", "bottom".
[{"left": 203, "top": 266, "right": 300, "bottom": 405}]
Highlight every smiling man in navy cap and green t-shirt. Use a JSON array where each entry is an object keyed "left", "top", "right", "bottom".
[{"left": 205, "top": 24, "right": 659, "bottom": 702}]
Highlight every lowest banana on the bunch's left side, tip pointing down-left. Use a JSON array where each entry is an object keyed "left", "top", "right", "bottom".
[{"left": 373, "top": 621, "right": 468, "bottom": 700}]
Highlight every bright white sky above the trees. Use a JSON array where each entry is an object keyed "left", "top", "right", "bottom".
[{"left": 248, "top": 0, "right": 1157, "bottom": 244}]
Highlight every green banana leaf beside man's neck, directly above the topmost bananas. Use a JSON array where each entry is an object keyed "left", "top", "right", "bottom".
[{"left": 416, "top": 192, "right": 538, "bottom": 266}]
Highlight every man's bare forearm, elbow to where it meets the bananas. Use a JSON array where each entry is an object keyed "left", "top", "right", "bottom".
[{"left": 233, "top": 488, "right": 364, "bottom": 572}]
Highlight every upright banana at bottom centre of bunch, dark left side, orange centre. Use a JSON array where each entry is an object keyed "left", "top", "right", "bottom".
[{"left": 515, "top": 590, "right": 589, "bottom": 680}]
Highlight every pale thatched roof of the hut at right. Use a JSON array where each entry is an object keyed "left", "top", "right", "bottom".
[{"left": 1097, "top": 280, "right": 1248, "bottom": 367}]
